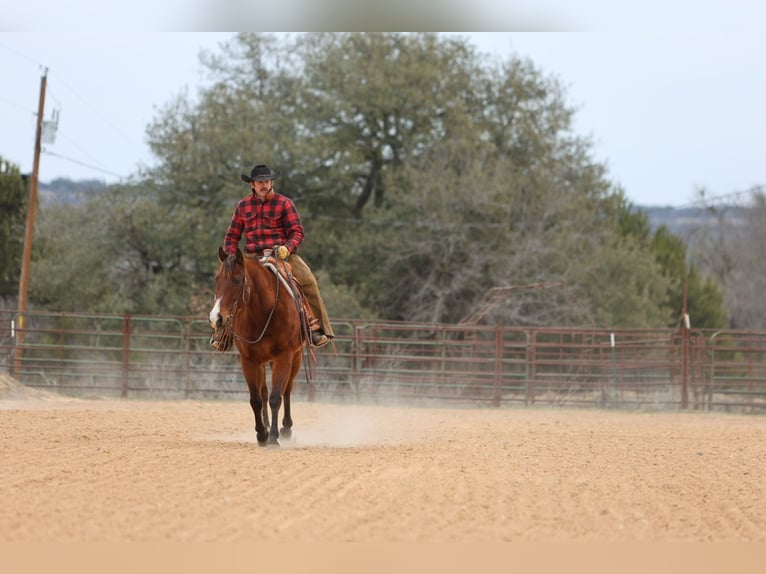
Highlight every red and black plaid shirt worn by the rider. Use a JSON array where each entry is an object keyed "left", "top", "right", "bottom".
[{"left": 223, "top": 191, "right": 303, "bottom": 255}]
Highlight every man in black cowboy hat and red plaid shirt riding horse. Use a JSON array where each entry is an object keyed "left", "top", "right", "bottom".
[{"left": 223, "top": 164, "right": 335, "bottom": 347}]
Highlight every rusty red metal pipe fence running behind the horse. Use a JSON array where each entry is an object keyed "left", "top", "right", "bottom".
[{"left": 0, "top": 309, "right": 766, "bottom": 413}]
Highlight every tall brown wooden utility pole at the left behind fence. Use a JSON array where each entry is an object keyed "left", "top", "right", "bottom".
[{"left": 14, "top": 68, "right": 48, "bottom": 374}]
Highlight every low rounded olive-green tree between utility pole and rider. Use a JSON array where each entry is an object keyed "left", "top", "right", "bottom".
[{"left": 31, "top": 185, "right": 214, "bottom": 315}]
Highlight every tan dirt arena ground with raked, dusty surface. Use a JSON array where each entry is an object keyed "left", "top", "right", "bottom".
[{"left": 0, "top": 378, "right": 766, "bottom": 542}]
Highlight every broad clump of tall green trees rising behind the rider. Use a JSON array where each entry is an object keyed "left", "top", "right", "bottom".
[{"left": 33, "top": 33, "right": 696, "bottom": 327}]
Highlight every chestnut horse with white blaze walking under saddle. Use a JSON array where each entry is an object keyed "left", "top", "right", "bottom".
[{"left": 210, "top": 247, "right": 306, "bottom": 446}]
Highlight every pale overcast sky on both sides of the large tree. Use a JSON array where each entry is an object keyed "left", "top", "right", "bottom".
[{"left": 0, "top": 20, "right": 766, "bottom": 206}]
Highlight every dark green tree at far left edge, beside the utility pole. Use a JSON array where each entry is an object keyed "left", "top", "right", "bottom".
[{"left": 0, "top": 157, "right": 27, "bottom": 298}]
